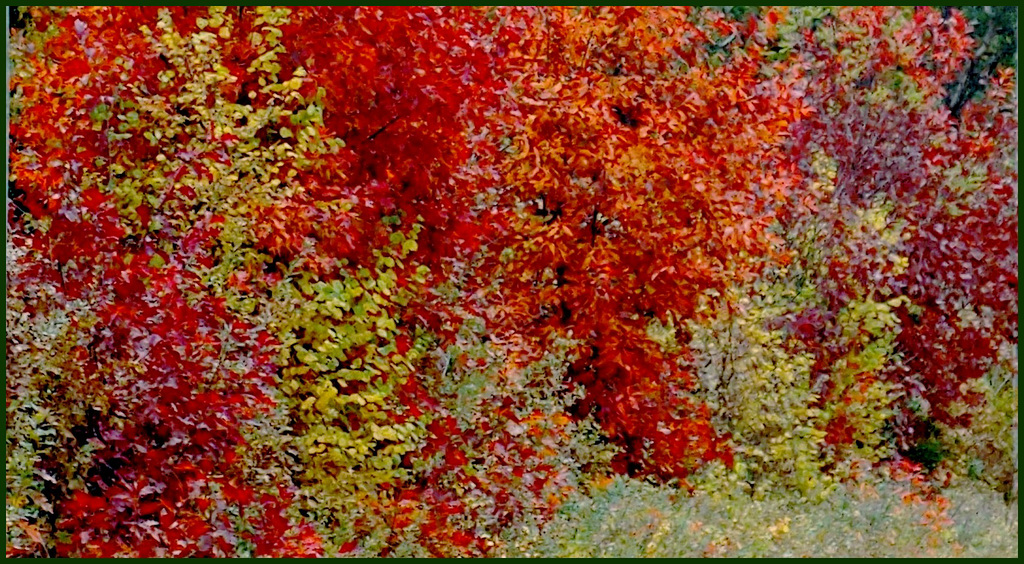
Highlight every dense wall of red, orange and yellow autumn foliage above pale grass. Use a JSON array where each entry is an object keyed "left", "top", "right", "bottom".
[{"left": 6, "top": 7, "right": 1018, "bottom": 557}]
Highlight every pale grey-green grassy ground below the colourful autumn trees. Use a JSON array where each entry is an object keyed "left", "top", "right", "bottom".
[{"left": 501, "top": 478, "right": 1017, "bottom": 558}]
